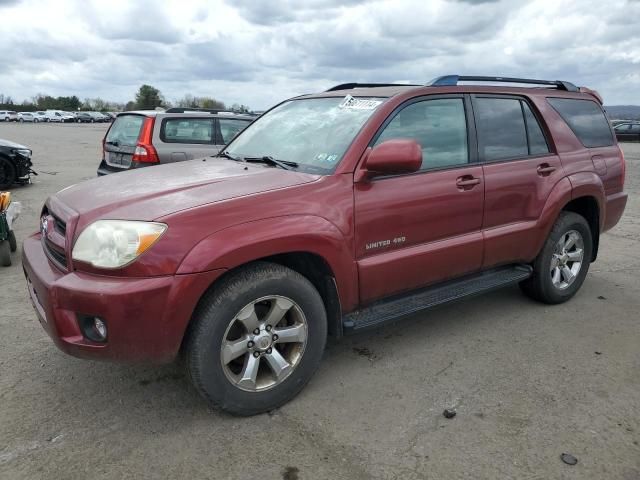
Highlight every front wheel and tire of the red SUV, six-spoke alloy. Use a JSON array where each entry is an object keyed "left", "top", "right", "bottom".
[{"left": 185, "top": 262, "right": 327, "bottom": 415}]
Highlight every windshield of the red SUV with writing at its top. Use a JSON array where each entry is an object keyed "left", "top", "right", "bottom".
[{"left": 226, "top": 95, "right": 386, "bottom": 174}]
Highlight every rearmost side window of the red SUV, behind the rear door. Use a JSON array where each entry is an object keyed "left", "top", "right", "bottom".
[{"left": 547, "top": 98, "right": 613, "bottom": 148}]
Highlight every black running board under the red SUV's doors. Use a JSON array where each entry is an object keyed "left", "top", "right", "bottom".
[{"left": 342, "top": 265, "right": 533, "bottom": 334}]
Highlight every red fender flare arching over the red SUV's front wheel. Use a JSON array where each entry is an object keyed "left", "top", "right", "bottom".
[{"left": 176, "top": 215, "right": 358, "bottom": 314}]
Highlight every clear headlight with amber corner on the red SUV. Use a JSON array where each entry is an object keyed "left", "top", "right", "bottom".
[{"left": 72, "top": 220, "right": 167, "bottom": 268}]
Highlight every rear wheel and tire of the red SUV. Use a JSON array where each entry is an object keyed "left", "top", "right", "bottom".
[{"left": 520, "top": 212, "right": 593, "bottom": 305}]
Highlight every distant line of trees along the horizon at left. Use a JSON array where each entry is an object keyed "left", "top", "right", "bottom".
[{"left": 0, "top": 84, "right": 251, "bottom": 113}]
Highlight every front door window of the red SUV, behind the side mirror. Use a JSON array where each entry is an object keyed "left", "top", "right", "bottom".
[{"left": 375, "top": 98, "right": 469, "bottom": 170}]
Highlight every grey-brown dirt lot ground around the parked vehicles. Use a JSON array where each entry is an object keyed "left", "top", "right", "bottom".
[{"left": 0, "top": 124, "right": 640, "bottom": 480}]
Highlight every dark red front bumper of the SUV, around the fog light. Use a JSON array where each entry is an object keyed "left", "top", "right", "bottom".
[{"left": 22, "top": 234, "right": 224, "bottom": 363}]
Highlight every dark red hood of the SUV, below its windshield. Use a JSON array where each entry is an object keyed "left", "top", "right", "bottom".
[{"left": 49, "top": 157, "right": 320, "bottom": 223}]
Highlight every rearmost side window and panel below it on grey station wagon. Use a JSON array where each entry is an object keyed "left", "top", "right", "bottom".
[{"left": 154, "top": 117, "right": 219, "bottom": 163}]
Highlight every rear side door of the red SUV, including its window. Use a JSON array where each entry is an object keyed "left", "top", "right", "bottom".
[{"left": 472, "top": 95, "right": 562, "bottom": 268}]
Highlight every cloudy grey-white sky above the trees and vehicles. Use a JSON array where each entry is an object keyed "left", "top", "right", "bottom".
[{"left": 0, "top": 0, "right": 640, "bottom": 109}]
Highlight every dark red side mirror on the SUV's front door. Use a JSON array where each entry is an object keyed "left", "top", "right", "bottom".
[{"left": 364, "top": 138, "right": 422, "bottom": 176}]
